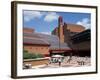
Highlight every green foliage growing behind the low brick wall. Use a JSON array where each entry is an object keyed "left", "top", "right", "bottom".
[{"left": 23, "top": 50, "right": 44, "bottom": 59}]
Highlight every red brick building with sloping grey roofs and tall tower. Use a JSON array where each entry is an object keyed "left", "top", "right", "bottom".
[{"left": 23, "top": 16, "right": 90, "bottom": 56}]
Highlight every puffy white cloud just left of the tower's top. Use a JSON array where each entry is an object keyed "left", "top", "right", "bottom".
[{"left": 44, "top": 12, "right": 59, "bottom": 22}]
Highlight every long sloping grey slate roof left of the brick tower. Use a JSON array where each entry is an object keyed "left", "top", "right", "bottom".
[{"left": 24, "top": 33, "right": 70, "bottom": 49}]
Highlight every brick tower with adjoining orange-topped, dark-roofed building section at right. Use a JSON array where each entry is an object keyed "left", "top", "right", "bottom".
[{"left": 52, "top": 16, "right": 91, "bottom": 56}]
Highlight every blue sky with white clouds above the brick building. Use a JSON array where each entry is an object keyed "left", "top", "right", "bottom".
[{"left": 23, "top": 10, "right": 91, "bottom": 34}]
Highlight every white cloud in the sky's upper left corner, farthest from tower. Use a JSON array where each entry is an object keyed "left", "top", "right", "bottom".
[{"left": 24, "top": 11, "right": 44, "bottom": 21}]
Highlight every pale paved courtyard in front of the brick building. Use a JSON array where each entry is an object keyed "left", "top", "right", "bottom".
[{"left": 32, "top": 56, "right": 91, "bottom": 69}]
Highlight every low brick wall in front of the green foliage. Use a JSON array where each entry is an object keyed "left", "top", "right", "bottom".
[{"left": 23, "top": 58, "right": 49, "bottom": 66}]
